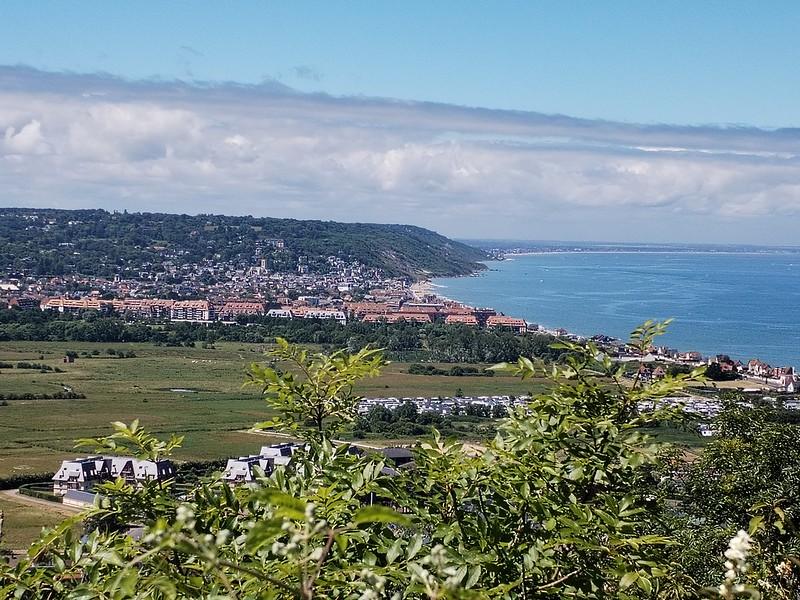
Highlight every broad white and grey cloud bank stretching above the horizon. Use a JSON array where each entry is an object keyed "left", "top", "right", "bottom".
[{"left": 0, "top": 67, "right": 800, "bottom": 243}]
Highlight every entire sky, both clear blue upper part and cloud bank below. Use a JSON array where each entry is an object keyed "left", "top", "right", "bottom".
[{"left": 0, "top": 1, "right": 800, "bottom": 243}]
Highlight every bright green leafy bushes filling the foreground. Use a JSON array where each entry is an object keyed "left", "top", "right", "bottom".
[{"left": 0, "top": 323, "right": 776, "bottom": 600}]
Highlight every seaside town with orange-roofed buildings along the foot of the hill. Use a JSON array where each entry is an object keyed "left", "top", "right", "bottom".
[{"left": 0, "top": 239, "right": 800, "bottom": 393}]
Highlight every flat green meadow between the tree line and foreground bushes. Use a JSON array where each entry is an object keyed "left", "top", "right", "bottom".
[{"left": 0, "top": 342, "right": 544, "bottom": 476}]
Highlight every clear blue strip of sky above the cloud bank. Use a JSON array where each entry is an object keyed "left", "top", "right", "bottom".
[{"left": 0, "top": 0, "right": 800, "bottom": 127}]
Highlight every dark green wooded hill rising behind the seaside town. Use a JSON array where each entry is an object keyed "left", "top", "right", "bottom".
[{"left": 0, "top": 208, "right": 487, "bottom": 278}]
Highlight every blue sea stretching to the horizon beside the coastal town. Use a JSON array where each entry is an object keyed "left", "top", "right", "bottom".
[{"left": 431, "top": 245, "right": 800, "bottom": 367}]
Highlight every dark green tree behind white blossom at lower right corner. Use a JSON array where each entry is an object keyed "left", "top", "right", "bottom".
[{"left": 672, "top": 396, "right": 800, "bottom": 598}]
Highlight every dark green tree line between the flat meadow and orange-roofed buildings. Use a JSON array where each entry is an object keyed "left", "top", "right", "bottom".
[{"left": 0, "top": 309, "right": 564, "bottom": 363}]
